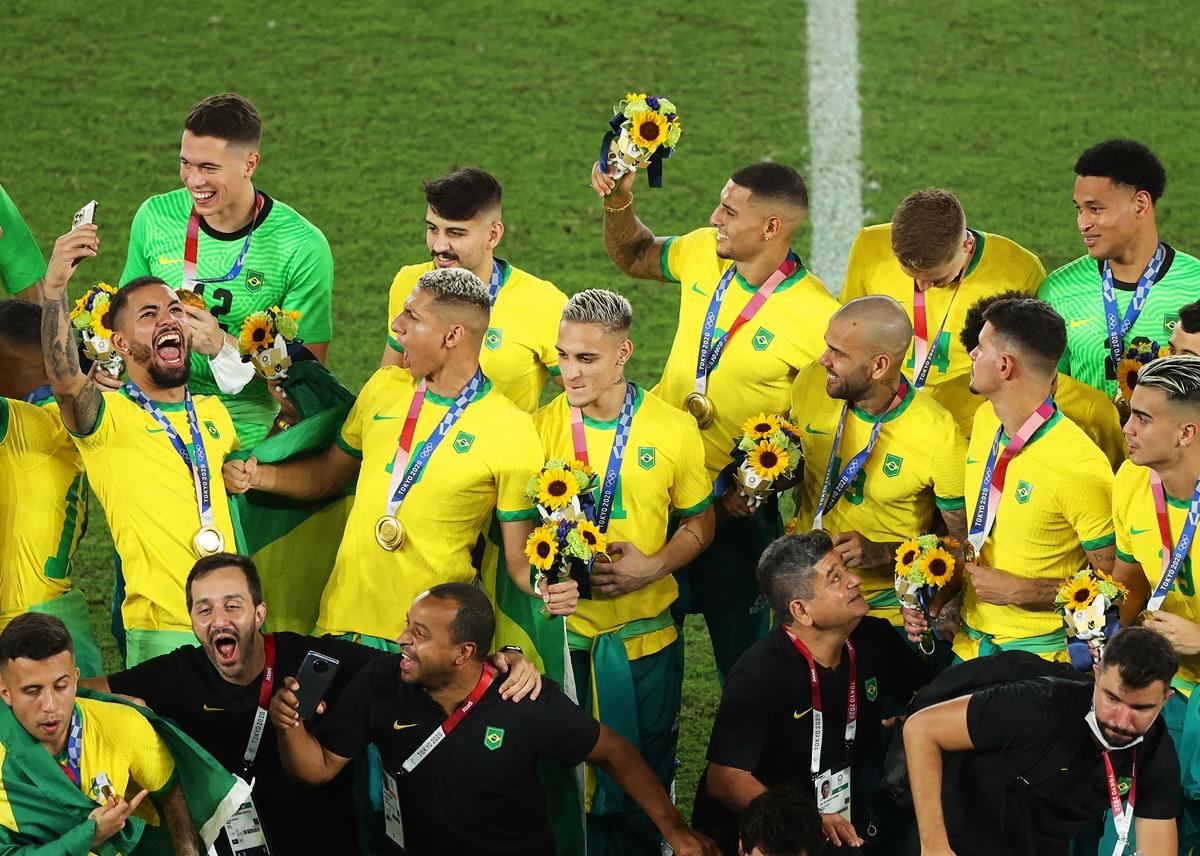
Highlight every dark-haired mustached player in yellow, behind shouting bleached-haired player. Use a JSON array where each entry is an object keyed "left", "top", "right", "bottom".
[{"left": 380, "top": 167, "right": 566, "bottom": 413}]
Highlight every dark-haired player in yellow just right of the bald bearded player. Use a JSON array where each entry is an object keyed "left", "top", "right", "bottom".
[{"left": 905, "top": 298, "right": 1115, "bottom": 662}]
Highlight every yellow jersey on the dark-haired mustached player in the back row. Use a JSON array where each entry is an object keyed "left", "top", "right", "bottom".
[{"left": 388, "top": 258, "right": 566, "bottom": 413}]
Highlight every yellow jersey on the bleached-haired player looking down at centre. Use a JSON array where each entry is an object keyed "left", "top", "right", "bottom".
[{"left": 533, "top": 387, "right": 713, "bottom": 659}]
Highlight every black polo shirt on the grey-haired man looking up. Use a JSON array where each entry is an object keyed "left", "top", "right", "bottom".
[{"left": 692, "top": 617, "right": 929, "bottom": 852}]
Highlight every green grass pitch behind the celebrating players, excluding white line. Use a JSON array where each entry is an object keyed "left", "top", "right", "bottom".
[{"left": 7, "top": 0, "right": 1200, "bottom": 825}]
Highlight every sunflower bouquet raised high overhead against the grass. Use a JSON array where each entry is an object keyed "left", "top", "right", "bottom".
[{"left": 600, "top": 92, "right": 683, "bottom": 187}]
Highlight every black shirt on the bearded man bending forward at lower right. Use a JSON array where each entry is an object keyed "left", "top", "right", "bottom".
[{"left": 942, "top": 680, "right": 1180, "bottom": 856}]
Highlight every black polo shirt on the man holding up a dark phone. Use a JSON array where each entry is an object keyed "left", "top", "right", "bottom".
[{"left": 317, "top": 654, "right": 600, "bottom": 856}]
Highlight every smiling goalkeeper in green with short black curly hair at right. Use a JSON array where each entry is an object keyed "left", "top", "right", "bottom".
[{"left": 1038, "top": 139, "right": 1200, "bottom": 397}]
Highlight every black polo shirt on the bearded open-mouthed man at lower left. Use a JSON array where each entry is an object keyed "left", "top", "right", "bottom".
[{"left": 108, "top": 633, "right": 383, "bottom": 854}]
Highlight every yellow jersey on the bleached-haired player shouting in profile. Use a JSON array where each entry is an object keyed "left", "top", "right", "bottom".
[{"left": 317, "top": 366, "right": 544, "bottom": 639}]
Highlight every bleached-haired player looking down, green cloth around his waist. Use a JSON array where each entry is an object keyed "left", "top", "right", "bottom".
[{"left": 534, "top": 289, "right": 715, "bottom": 855}]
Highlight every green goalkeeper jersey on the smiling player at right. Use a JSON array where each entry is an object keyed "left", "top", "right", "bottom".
[{"left": 1038, "top": 244, "right": 1200, "bottom": 396}]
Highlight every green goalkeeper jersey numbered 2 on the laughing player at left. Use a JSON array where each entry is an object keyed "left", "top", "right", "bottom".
[{"left": 121, "top": 187, "right": 334, "bottom": 448}]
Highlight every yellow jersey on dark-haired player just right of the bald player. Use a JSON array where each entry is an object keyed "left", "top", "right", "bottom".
[{"left": 954, "top": 402, "right": 1114, "bottom": 659}]
